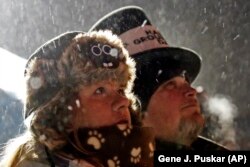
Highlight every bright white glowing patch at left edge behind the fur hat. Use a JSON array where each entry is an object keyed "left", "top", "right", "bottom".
[{"left": 0, "top": 48, "right": 27, "bottom": 100}]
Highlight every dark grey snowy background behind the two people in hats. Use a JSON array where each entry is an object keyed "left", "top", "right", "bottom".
[{"left": 0, "top": 0, "right": 250, "bottom": 150}]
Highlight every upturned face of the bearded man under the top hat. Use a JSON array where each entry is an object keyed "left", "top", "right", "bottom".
[{"left": 144, "top": 76, "right": 204, "bottom": 145}]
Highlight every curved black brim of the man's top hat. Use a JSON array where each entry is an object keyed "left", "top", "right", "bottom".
[{"left": 133, "top": 47, "right": 201, "bottom": 83}]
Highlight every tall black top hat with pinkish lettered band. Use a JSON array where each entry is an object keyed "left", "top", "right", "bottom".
[{"left": 90, "top": 6, "right": 201, "bottom": 110}]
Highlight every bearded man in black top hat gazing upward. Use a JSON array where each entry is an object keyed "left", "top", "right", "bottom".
[{"left": 90, "top": 6, "right": 229, "bottom": 150}]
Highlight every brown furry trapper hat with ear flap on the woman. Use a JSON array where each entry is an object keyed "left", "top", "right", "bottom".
[{"left": 25, "top": 31, "right": 135, "bottom": 148}]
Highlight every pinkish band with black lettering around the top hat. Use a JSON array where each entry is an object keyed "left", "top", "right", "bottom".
[{"left": 120, "top": 25, "right": 168, "bottom": 55}]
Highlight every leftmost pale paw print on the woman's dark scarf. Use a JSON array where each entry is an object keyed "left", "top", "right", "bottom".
[{"left": 87, "top": 130, "right": 105, "bottom": 150}]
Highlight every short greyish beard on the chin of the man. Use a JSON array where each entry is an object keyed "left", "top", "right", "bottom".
[{"left": 176, "top": 119, "right": 203, "bottom": 146}]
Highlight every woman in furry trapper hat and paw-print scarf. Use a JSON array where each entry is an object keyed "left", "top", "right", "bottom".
[{"left": 1, "top": 31, "right": 154, "bottom": 167}]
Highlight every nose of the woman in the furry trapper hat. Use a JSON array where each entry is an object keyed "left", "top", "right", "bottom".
[{"left": 113, "top": 93, "right": 130, "bottom": 111}]
